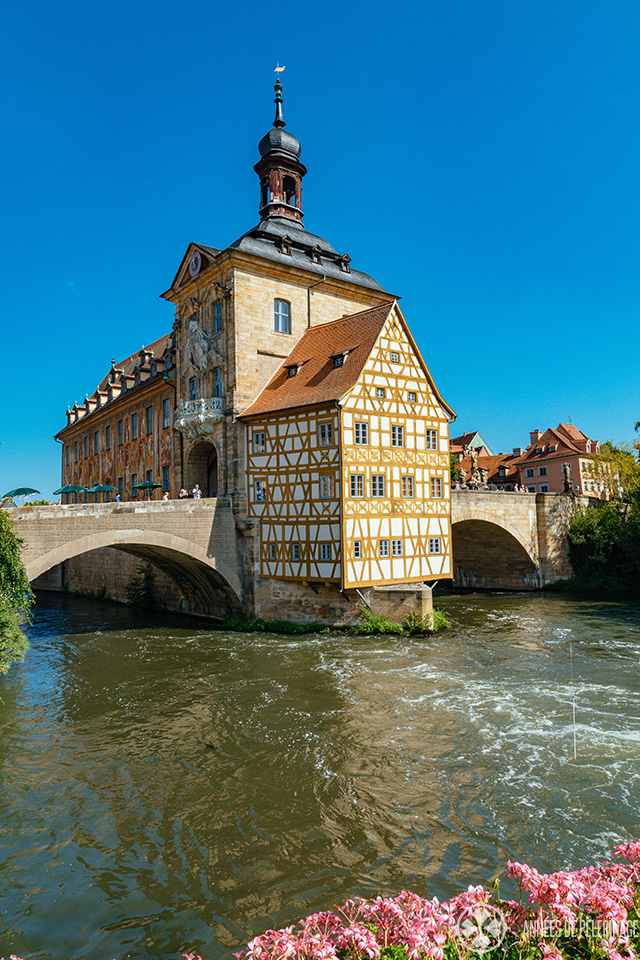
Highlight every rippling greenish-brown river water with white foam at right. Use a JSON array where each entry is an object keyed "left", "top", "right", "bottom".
[{"left": 0, "top": 594, "right": 640, "bottom": 960}]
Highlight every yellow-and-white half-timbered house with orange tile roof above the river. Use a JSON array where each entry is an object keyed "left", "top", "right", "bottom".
[{"left": 243, "top": 302, "right": 452, "bottom": 589}]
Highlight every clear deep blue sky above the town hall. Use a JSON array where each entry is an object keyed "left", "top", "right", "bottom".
[{"left": 0, "top": 0, "right": 640, "bottom": 495}]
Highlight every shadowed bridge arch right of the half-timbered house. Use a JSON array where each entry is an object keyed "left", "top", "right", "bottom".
[{"left": 451, "top": 516, "right": 540, "bottom": 590}]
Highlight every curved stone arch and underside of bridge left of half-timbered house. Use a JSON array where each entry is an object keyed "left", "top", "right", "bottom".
[{"left": 25, "top": 529, "right": 243, "bottom": 619}]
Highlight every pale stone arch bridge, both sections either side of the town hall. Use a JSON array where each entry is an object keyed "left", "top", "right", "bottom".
[{"left": 9, "top": 490, "right": 575, "bottom": 619}]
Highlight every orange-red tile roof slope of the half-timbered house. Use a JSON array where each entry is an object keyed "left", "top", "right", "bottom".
[{"left": 242, "top": 301, "right": 395, "bottom": 417}]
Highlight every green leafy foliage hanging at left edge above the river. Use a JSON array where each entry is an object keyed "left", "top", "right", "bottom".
[{"left": 0, "top": 510, "right": 34, "bottom": 676}]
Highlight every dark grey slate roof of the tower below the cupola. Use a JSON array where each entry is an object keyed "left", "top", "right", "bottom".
[{"left": 229, "top": 217, "right": 384, "bottom": 291}]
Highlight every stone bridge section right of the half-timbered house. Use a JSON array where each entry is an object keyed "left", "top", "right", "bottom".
[{"left": 451, "top": 490, "right": 589, "bottom": 590}]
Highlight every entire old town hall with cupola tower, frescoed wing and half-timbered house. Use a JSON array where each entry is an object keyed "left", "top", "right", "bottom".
[{"left": 58, "top": 79, "right": 453, "bottom": 619}]
